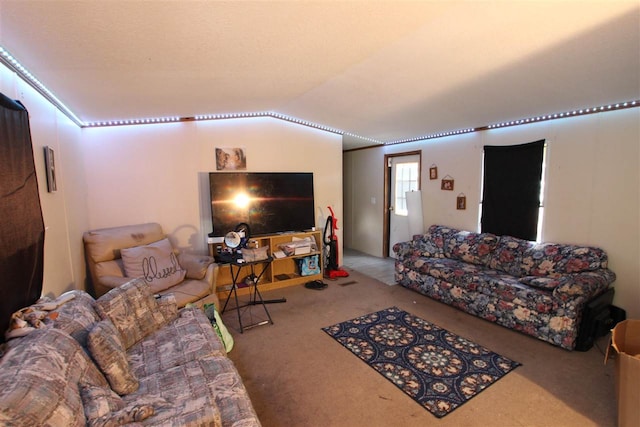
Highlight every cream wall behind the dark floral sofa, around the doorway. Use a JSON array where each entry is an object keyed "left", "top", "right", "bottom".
[{"left": 344, "top": 108, "right": 640, "bottom": 318}]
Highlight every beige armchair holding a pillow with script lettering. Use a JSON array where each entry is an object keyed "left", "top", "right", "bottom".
[{"left": 83, "top": 223, "right": 220, "bottom": 309}]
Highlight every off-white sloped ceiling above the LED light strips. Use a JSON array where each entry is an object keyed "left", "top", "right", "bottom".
[{"left": 0, "top": 0, "right": 640, "bottom": 149}]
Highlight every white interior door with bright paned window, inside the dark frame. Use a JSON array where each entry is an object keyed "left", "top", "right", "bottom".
[{"left": 388, "top": 154, "right": 422, "bottom": 258}]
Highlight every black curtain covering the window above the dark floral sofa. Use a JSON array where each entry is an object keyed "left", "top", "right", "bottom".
[{"left": 481, "top": 139, "right": 544, "bottom": 240}]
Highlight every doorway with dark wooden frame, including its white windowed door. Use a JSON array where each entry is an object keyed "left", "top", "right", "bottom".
[{"left": 382, "top": 151, "right": 422, "bottom": 258}]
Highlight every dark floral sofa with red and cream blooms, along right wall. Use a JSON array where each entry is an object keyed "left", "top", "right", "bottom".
[{"left": 393, "top": 225, "right": 615, "bottom": 350}]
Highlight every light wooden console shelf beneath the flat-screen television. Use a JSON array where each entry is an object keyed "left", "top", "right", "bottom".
[{"left": 209, "top": 231, "right": 324, "bottom": 301}]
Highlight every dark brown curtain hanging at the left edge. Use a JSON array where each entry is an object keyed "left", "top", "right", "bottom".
[{"left": 0, "top": 93, "right": 44, "bottom": 342}]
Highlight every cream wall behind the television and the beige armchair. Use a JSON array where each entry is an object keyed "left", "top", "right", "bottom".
[{"left": 82, "top": 118, "right": 342, "bottom": 253}]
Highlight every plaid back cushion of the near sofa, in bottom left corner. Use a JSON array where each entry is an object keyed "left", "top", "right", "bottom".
[{"left": 0, "top": 328, "right": 107, "bottom": 427}]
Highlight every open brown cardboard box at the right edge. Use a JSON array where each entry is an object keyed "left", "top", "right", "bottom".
[{"left": 605, "top": 320, "right": 640, "bottom": 427}]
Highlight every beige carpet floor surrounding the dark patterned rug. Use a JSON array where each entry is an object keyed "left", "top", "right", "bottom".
[{"left": 223, "top": 270, "right": 616, "bottom": 427}]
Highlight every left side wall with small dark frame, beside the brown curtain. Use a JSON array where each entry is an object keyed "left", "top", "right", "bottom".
[{"left": 0, "top": 65, "right": 87, "bottom": 295}]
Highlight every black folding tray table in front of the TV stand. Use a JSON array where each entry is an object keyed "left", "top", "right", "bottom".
[{"left": 220, "top": 257, "right": 273, "bottom": 334}]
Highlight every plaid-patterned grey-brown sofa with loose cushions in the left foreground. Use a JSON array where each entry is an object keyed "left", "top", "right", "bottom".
[{"left": 0, "top": 279, "right": 260, "bottom": 427}]
